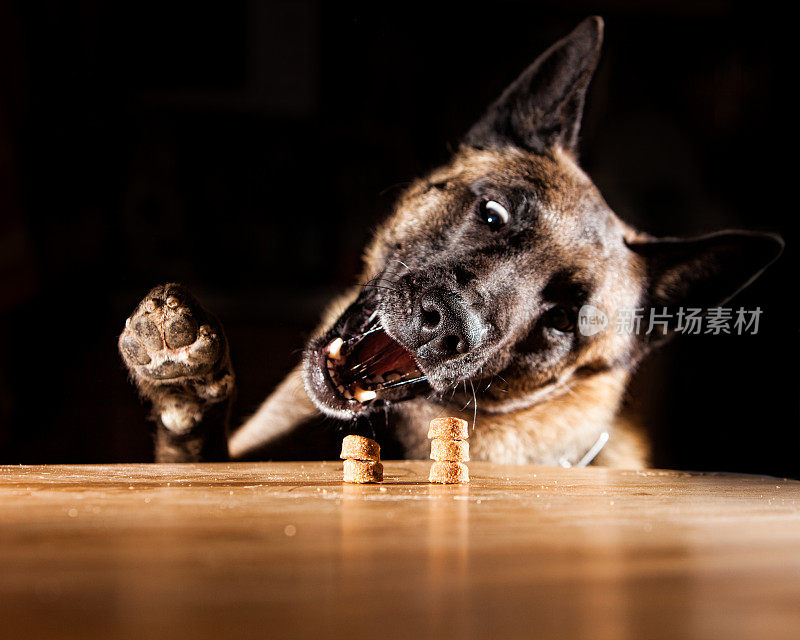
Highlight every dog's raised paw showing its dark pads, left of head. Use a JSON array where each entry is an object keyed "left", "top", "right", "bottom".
[{"left": 119, "top": 284, "right": 233, "bottom": 401}]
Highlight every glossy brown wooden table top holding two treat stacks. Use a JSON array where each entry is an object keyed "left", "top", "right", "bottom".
[{"left": 0, "top": 462, "right": 800, "bottom": 640}]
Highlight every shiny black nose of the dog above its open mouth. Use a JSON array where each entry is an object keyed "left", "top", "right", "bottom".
[{"left": 416, "top": 287, "right": 484, "bottom": 358}]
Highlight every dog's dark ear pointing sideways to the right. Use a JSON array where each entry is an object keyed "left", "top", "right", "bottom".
[{"left": 628, "top": 231, "right": 784, "bottom": 316}]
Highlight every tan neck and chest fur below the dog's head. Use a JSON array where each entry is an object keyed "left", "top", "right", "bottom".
[{"left": 393, "top": 369, "right": 648, "bottom": 468}]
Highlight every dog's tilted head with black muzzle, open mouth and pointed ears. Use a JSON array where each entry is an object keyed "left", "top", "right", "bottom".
[{"left": 304, "top": 18, "right": 782, "bottom": 418}]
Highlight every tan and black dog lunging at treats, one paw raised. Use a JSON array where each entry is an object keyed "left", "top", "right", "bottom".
[{"left": 119, "top": 18, "right": 783, "bottom": 467}]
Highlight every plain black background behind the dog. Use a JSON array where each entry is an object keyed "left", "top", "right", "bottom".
[{"left": 0, "top": 1, "right": 800, "bottom": 476}]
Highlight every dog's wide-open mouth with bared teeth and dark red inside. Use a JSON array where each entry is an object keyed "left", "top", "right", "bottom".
[{"left": 305, "top": 302, "right": 427, "bottom": 418}]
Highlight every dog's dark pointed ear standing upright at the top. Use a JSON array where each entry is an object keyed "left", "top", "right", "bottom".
[{"left": 463, "top": 16, "right": 603, "bottom": 154}]
